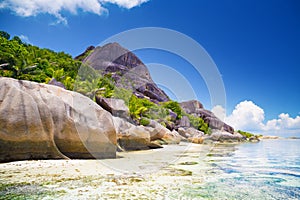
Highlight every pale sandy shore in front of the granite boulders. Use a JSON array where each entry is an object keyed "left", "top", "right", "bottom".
[{"left": 0, "top": 143, "right": 216, "bottom": 199}]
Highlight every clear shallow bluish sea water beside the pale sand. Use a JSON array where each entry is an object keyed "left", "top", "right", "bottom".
[{"left": 179, "top": 139, "right": 300, "bottom": 200}]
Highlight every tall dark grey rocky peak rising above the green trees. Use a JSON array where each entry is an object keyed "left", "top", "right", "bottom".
[{"left": 83, "top": 43, "right": 169, "bottom": 102}]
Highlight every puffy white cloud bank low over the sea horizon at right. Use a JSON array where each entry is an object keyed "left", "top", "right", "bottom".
[{"left": 212, "top": 101, "right": 300, "bottom": 133}]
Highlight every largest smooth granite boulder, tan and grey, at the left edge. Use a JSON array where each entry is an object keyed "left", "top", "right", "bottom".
[{"left": 0, "top": 77, "right": 117, "bottom": 162}]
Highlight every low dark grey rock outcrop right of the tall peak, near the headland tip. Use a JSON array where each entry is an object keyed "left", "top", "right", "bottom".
[{"left": 180, "top": 100, "right": 234, "bottom": 134}]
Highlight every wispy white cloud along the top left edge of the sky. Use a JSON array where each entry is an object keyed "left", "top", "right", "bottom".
[{"left": 0, "top": 0, "right": 149, "bottom": 24}]
